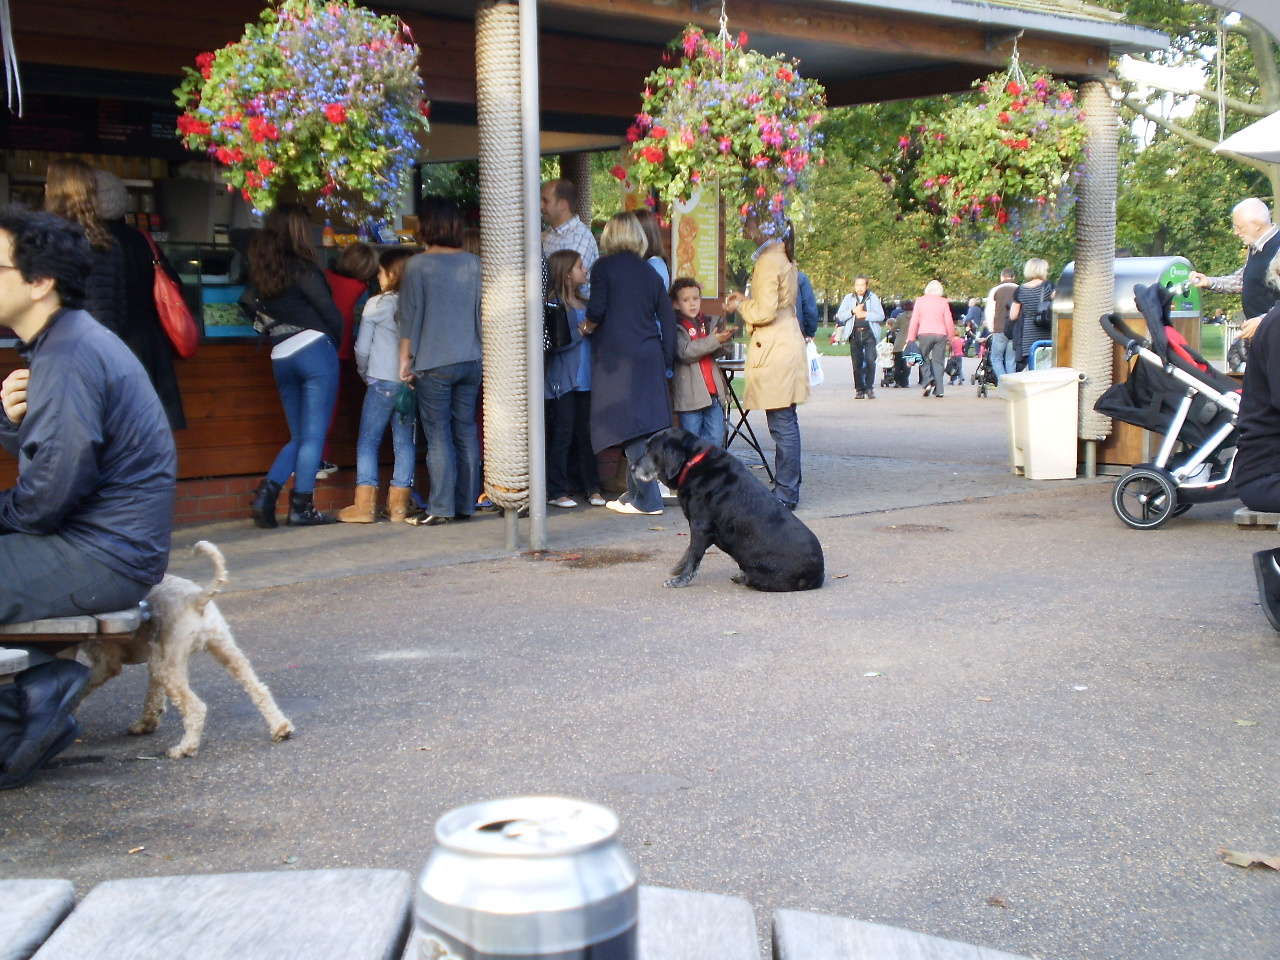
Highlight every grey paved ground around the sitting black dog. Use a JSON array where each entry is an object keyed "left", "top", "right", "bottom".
[{"left": 0, "top": 358, "right": 1280, "bottom": 960}]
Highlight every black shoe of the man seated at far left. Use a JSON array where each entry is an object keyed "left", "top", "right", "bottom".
[{"left": 0, "top": 658, "right": 91, "bottom": 790}]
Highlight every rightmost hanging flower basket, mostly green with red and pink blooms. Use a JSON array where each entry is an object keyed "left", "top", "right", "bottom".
[{"left": 899, "top": 61, "right": 1085, "bottom": 230}]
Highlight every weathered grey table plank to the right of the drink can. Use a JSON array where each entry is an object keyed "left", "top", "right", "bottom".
[{"left": 773, "top": 910, "right": 1027, "bottom": 960}]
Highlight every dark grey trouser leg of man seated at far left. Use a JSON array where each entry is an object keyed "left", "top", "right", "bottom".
[{"left": 0, "top": 534, "right": 151, "bottom": 627}]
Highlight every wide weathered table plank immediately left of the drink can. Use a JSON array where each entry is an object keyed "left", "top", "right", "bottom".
[{"left": 36, "top": 870, "right": 413, "bottom": 960}]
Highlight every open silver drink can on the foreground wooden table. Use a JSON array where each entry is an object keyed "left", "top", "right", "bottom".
[{"left": 410, "top": 796, "right": 639, "bottom": 960}]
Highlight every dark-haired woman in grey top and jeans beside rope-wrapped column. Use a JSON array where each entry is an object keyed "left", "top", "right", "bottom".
[{"left": 396, "top": 196, "right": 480, "bottom": 526}]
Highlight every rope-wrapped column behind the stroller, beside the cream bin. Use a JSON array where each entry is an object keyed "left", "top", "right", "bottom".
[{"left": 1071, "top": 81, "right": 1119, "bottom": 448}]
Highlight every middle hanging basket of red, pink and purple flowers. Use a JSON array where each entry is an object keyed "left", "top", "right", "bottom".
[{"left": 614, "top": 26, "right": 826, "bottom": 236}]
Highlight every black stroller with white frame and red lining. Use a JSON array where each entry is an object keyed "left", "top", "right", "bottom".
[{"left": 1093, "top": 284, "right": 1240, "bottom": 530}]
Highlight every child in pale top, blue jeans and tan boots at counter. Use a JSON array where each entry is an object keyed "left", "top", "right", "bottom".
[{"left": 338, "top": 248, "right": 417, "bottom": 524}]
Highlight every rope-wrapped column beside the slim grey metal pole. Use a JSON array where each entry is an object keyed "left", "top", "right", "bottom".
[{"left": 476, "top": 4, "right": 536, "bottom": 511}]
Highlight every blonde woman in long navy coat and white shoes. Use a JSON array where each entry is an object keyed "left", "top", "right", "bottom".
[{"left": 582, "top": 214, "right": 676, "bottom": 516}]
